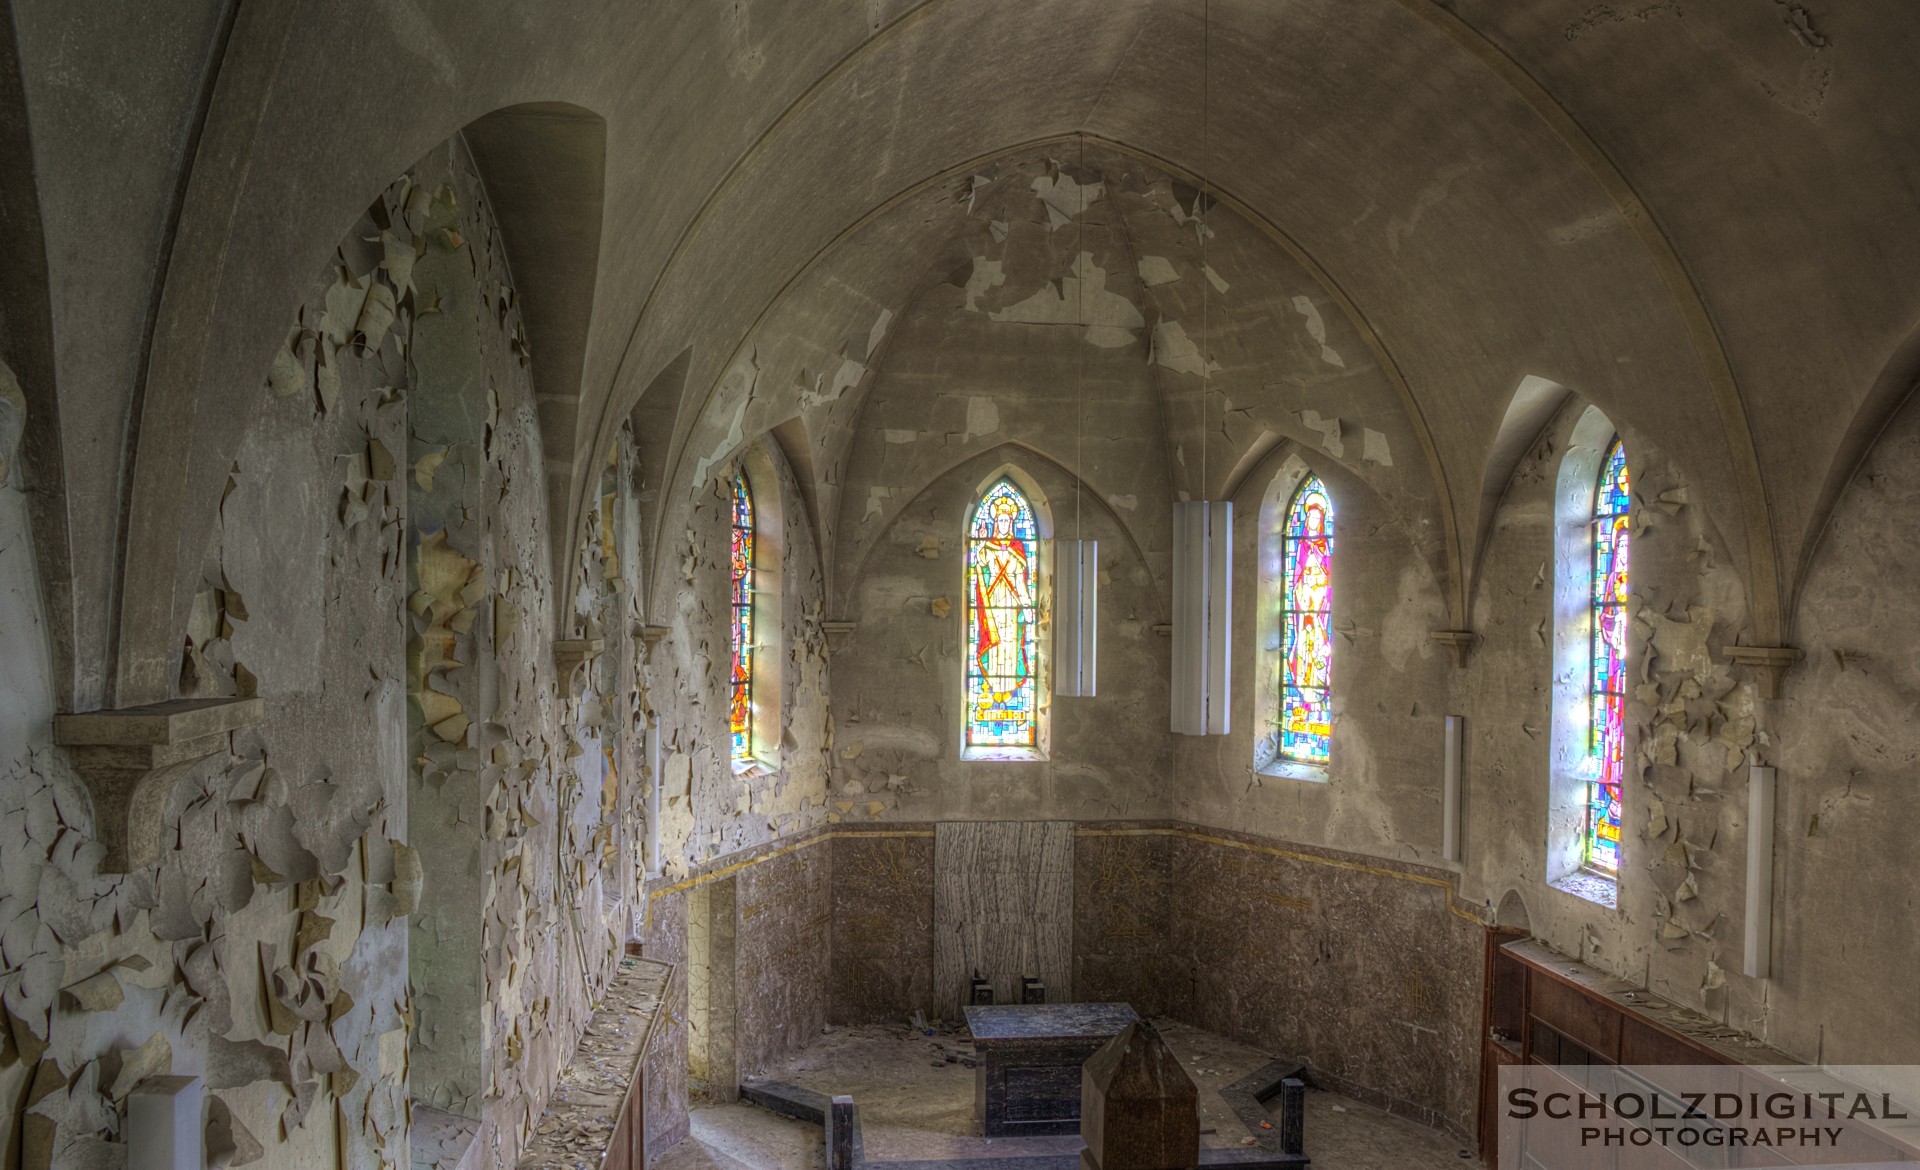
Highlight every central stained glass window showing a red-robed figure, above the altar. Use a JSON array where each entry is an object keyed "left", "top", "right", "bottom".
[{"left": 966, "top": 480, "right": 1041, "bottom": 747}]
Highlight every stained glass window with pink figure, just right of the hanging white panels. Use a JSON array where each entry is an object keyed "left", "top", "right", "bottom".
[{"left": 1281, "top": 475, "right": 1332, "bottom": 765}]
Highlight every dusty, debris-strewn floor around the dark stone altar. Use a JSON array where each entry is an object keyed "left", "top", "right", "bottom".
[{"left": 653, "top": 1020, "right": 1476, "bottom": 1170}]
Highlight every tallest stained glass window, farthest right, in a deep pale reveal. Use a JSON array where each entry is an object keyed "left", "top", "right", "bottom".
[{"left": 1586, "top": 436, "right": 1628, "bottom": 874}]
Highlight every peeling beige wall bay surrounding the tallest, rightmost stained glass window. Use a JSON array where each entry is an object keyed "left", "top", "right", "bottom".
[{"left": 1457, "top": 402, "right": 1766, "bottom": 1059}]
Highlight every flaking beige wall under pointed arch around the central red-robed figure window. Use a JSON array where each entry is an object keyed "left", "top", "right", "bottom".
[{"left": 828, "top": 450, "right": 1171, "bottom": 822}]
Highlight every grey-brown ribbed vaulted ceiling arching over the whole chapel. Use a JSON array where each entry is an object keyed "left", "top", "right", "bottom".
[{"left": 8, "top": 0, "right": 1920, "bottom": 701}]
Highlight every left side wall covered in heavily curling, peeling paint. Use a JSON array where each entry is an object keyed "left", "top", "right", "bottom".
[{"left": 0, "top": 146, "right": 639, "bottom": 1168}]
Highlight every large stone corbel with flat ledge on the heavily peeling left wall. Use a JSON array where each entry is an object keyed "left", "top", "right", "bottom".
[{"left": 54, "top": 699, "right": 267, "bottom": 874}]
